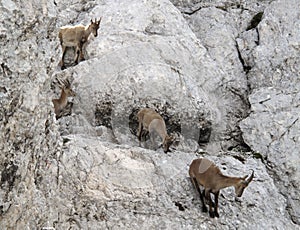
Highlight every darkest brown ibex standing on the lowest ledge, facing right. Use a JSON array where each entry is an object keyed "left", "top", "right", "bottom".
[{"left": 189, "top": 158, "right": 254, "bottom": 218}]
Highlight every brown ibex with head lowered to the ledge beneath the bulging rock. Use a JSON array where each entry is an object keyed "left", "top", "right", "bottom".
[{"left": 137, "top": 108, "right": 175, "bottom": 153}]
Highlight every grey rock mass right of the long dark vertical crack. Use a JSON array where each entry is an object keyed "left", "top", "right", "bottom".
[{"left": 240, "top": 0, "right": 300, "bottom": 224}]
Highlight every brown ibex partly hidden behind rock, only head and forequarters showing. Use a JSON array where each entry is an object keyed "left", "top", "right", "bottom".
[{"left": 52, "top": 80, "right": 76, "bottom": 119}]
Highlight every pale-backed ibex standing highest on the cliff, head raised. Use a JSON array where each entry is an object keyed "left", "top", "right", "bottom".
[{"left": 58, "top": 17, "right": 102, "bottom": 69}]
